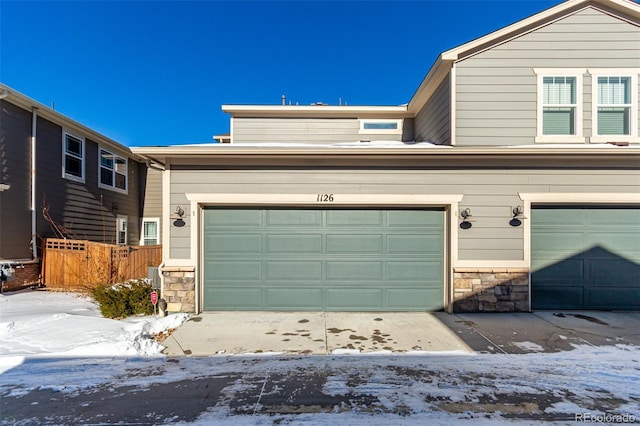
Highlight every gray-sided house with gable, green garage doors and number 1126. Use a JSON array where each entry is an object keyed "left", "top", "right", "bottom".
[{"left": 132, "top": 0, "right": 640, "bottom": 312}]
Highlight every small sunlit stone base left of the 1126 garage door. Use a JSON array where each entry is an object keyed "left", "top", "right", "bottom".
[{"left": 162, "top": 267, "right": 196, "bottom": 313}]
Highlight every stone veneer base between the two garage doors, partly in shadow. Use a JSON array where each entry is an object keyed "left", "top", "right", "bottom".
[{"left": 453, "top": 268, "right": 531, "bottom": 312}]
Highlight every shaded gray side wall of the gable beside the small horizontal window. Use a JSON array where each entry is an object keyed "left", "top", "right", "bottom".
[{"left": 415, "top": 75, "right": 451, "bottom": 145}]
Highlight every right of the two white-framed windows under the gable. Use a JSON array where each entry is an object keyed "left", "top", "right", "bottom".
[{"left": 592, "top": 70, "right": 638, "bottom": 142}]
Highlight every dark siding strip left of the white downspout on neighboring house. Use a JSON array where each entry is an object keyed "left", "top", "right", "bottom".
[{"left": 0, "top": 101, "right": 31, "bottom": 259}]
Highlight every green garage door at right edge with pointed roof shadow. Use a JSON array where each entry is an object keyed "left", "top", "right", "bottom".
[{"left": 531, "top": 206, "right": 640, "bottom": 310}]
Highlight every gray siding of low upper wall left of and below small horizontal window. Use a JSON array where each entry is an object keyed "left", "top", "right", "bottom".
[{"left": 232, "top": 117, "right": 402, "bottom": 144}]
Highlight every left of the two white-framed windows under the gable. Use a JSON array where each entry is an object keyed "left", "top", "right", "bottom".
[{"left": 535, "top": 69, "right": 584, "bottom": 143}]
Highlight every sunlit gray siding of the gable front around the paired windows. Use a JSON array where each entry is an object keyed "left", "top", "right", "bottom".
[{"left": 455, "top": 8, "right": 640, "bottom": 146}]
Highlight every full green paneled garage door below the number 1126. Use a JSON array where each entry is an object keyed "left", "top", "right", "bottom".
[{"left": 203, "top": 208, "right": 444, "bottom": 311}]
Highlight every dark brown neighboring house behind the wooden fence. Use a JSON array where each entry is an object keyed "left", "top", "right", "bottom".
[{"left": 0, "top": 85, "right": 161, "bottom": 285}]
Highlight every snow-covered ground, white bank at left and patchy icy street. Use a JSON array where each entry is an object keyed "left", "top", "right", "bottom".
[{"left": 0, "top": 291, "right": 640, "bottom": 425}]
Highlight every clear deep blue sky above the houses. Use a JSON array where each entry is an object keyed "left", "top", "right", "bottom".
[{"left": 0, "top": 0, "right": 560, "bottom": 146}]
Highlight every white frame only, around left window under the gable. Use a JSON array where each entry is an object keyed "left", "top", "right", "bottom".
[{"left": 533, "top": 68, "right": 586, "bottom": 143}]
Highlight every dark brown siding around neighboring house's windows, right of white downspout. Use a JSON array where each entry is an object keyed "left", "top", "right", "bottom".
[{"left": 36, "top": 118, "right": 140, "bottom": 244}]
